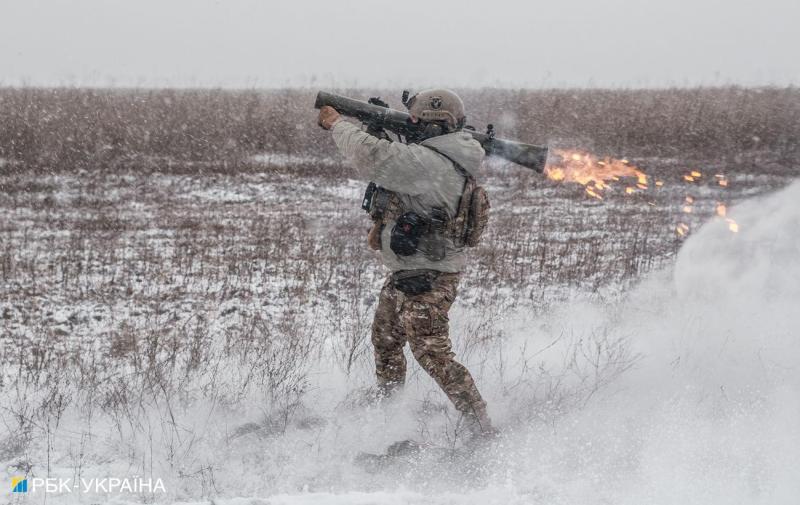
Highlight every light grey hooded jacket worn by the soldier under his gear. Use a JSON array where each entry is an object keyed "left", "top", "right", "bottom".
[{"left": 331, "top": 121, "right": 485, "bottom": 272}]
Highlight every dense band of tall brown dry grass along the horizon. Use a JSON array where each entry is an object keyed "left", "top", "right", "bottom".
[{"left": 0, "top": 87, "right": 800, "bottom": 172}]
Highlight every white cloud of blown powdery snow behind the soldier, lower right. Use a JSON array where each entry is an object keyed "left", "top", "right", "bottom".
[{"left": 253, "top": 179, "right": 800, "bottom": 504}]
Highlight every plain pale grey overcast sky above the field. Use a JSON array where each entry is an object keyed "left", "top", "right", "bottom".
[{"left": 0, "top": 0, "right": 800, "bottom": 88}]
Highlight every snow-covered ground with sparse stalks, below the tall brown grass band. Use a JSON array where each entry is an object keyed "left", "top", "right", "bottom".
[{"left": 0, "top": 155, "right": 800, "bottom": 505}]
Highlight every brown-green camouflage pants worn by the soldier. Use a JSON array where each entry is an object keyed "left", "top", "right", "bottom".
[{"left": 372, "top": 273, "right": 489, "bottom": 426}]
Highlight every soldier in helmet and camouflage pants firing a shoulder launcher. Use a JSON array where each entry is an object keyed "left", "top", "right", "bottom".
[{"left": 319, "top": 89, "right": 495, "bottom": 436}]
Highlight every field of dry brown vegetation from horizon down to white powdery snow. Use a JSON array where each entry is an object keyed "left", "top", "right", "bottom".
[{"left": 0, "top": 88, "right": 800, "bottom": 496}]
